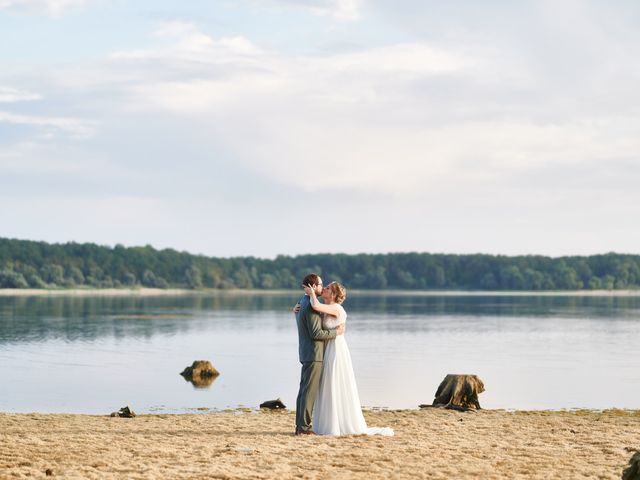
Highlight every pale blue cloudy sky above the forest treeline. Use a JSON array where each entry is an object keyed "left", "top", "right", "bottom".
[{"left": 0, "top": 0, "right": 640, "bottom": 258}]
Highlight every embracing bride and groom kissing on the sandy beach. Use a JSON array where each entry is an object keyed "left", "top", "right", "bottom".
[{"left": 294, "top": 273, "right": 393, "bottom": 436}]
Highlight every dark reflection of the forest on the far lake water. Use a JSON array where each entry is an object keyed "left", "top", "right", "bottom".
[{"left": 0, "top": 292, "right": 640, "bottom": 345}]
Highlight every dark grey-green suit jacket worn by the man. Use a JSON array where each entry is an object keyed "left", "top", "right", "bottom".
[{"left": 296, "top": 295, "right": 336, "bottom": 363}]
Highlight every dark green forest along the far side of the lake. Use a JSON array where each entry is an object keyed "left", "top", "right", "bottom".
[{"left": 0, "top": 238, "right": 640, "bottom": 290}]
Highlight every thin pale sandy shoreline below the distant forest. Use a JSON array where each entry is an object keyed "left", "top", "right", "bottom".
[{"left": 0, "top": 287, "right": 640, "bottom": 297}]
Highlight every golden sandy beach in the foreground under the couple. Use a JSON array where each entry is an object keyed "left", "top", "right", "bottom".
[{"left": 0, "top": 409, "right": 640, "bottom": 480}]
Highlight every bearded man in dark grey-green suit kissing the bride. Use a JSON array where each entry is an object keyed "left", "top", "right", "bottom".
[{"left": 296, "top": 273, "right": 344, "bottom": 435}]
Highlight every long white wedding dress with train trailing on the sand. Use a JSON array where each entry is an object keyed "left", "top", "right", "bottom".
[{"left": 313, "top": 305, "right": 393, "bottom": 436}]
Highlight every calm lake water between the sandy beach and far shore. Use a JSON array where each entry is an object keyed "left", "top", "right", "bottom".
[{"left": 0, "top": 292, "right": 640, "bottom": 414}]
